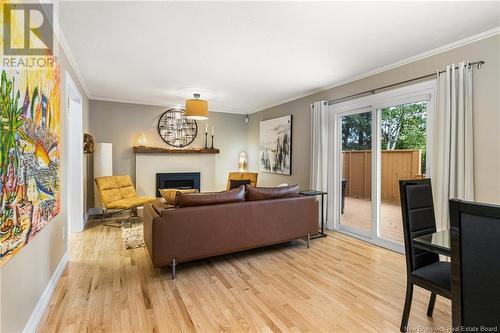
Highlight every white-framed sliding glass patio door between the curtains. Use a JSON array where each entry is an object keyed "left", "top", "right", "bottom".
[{"left": 335, "top": 83, "right": 434, "bottom": 251}]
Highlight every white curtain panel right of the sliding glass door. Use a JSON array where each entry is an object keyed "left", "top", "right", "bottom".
[{"left": 431, "top": 62, "right": 474, "bottom": 230}]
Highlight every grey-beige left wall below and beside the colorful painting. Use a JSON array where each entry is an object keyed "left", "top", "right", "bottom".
[{"left": 0, "top": 40, "right": 89, "bottom": 332}]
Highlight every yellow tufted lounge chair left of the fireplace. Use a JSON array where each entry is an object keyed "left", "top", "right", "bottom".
[{"left": 95, "top": 175, "right": 156, "bottom": 223}]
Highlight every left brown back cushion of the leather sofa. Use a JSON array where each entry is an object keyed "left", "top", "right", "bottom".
[{"left": 176, "top": 186, "right": 245, "bottom": 207}]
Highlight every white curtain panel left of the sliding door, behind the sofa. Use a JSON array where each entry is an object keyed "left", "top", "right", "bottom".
[{"left": 310, "top": 101, "right": 335, "bottom": 229}]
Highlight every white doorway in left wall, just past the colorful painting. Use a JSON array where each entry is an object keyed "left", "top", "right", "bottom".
[{"left": 64, "top": 72, "right": 84, "bottom": 236}]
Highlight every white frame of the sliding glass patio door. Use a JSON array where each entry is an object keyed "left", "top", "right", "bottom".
[{"left": 333, "top": 79, "right": 436, "bottom": 253}]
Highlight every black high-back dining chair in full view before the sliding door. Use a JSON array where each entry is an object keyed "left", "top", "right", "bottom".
[{"left": 399, "top": 179, "right": 451, "bottom": 332}]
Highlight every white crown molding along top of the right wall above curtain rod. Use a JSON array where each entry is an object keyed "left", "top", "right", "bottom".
[{"left": 249, "top": 26, "right": 500, "bottom": 114}]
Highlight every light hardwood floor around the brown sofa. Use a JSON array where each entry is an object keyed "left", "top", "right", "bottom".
[{"left": 39, "top": 219, "right": 451, "bottom": 332}]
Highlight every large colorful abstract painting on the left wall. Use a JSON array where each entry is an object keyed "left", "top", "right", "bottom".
[{"left": 0, "top": 4, "right": 61, "bottom": 267}]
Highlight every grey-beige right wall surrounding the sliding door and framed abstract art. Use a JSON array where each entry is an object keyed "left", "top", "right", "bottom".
[{"left": 248, "top": 35, "right": 500, "bottom": 203}]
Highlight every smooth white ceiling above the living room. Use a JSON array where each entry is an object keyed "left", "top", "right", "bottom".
[{"left": 60, "top": 1, "right": 500, "bottom": 113}]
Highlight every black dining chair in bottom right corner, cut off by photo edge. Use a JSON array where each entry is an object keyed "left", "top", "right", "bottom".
[{"left": 450, "top": 199, "right": 500, "bottom": 332}]
